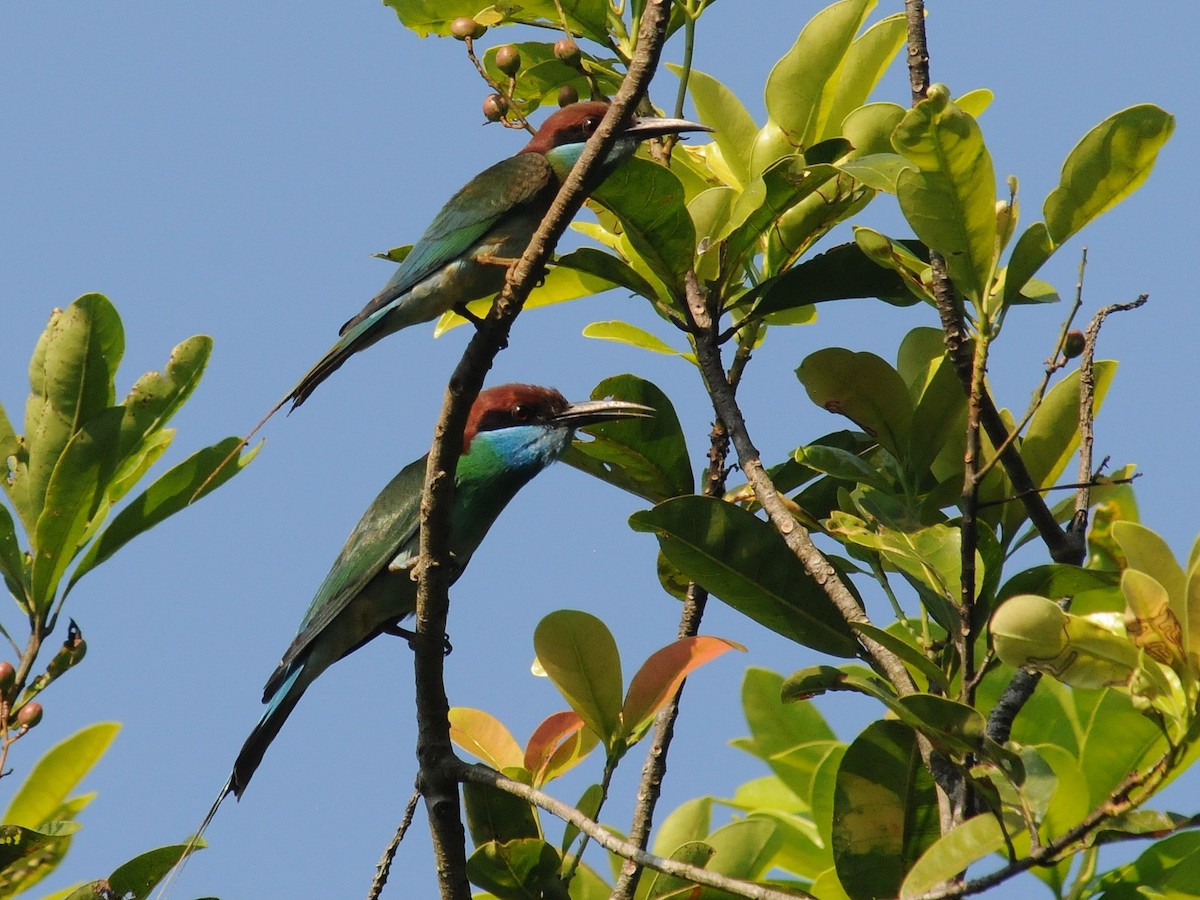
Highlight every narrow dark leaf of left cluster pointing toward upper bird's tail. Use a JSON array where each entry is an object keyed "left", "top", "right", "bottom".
[{"left": 67, "top": 437, "right": 258, "bottom": 600}]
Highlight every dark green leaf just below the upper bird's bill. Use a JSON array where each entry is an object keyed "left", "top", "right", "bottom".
[{"left": 592, "top": 158, "right": 696, "bottom": 298}]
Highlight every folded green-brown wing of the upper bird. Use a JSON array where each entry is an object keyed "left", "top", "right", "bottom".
[{"left": 342, "top": 154, "right": 554, "bottom": 334}]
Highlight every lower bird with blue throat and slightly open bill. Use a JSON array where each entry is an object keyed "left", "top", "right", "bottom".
[{"left": 231, "top": 384, "right": 654, "bottom": 801}]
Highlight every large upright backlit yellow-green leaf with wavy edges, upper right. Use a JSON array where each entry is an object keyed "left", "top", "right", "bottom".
[{"left": 892, "top": 85, "right": 996, "bottom": 304}]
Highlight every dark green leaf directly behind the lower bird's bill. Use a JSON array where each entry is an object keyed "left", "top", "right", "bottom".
[{"left": 564, "top": 374, "right": 694, "bottom": 503}]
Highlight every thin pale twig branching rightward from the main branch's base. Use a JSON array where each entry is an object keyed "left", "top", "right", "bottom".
[{"left": 455, "top": 762, "right": 812, "bottom": 900}]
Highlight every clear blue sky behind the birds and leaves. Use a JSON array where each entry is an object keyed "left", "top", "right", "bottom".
[{"left": 0, "top": 0, "right": 1200, "bottom": 898}]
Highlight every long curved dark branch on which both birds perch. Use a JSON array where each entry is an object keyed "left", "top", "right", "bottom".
[{"left": 414, "top": 0, "right": 670, "bottom": 900}]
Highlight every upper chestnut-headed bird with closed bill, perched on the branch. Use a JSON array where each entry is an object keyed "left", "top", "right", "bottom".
[{"left": 280, "top": 101, "right": 712, "bottom": 412}]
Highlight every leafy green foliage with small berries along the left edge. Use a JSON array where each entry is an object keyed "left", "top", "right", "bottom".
[{"left": 0, "top": 294, "right": 253, "bottom": 898}]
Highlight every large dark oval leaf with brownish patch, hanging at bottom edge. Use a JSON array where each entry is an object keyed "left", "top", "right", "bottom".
[{"left": 833, "top": 721, "right": 941, "bottom": 900}]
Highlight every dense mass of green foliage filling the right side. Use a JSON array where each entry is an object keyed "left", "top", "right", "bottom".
[{"left": 374, "top": 0, "right": 1200, "bottom": 898}]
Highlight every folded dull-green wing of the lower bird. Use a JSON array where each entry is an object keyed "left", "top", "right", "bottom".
[{"left": 268, "top": 457, "right": 425, "bottom": 686}]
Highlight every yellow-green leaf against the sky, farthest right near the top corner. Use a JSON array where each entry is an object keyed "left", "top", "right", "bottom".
[{"left": 1043, "top": 103, "right": 1175, "bottom": 245}]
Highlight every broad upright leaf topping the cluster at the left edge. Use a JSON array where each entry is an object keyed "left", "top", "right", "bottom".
[{"left": 6, "top": 294, "right": 125, "bottom": 534}]
